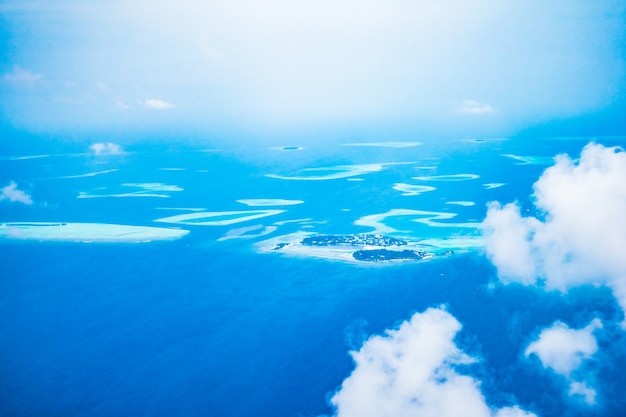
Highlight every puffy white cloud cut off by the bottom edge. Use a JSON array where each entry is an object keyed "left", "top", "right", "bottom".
[{"left": 331, "top": 308, "right": 534, "bottom": 417}]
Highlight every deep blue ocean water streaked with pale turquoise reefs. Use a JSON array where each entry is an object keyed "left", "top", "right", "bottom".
[{"left": 0, "top": 138, "right": 626, "bottom": 417}]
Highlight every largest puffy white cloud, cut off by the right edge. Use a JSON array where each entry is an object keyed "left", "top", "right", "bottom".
[{"left": 482, "top": 143, "right": 626, "bottom": 324}]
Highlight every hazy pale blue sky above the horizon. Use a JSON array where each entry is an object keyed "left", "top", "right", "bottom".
[{"left": 0, "top": 0, "right": 626, "bottom": 138}]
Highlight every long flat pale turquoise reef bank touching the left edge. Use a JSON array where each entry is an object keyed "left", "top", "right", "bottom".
[{"left": 0, "top": 222, "right": 189, "bottom": 243}]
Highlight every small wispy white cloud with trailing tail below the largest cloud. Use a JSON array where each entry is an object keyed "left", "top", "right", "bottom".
[{"left": 524, "top": 319, "right": 602, "bottom": 404}]
